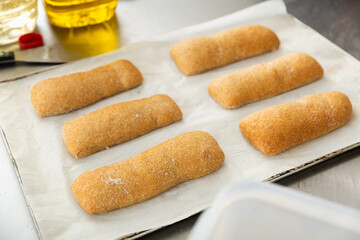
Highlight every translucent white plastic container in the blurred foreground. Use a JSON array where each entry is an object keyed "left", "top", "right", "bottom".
[{"left": 189, "top": 183, "right": 360, "bottom": 240}]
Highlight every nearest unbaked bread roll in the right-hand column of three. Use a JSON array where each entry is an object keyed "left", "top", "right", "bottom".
[{"left": 239, "top": 92, "right": 352, "bottom": 155}]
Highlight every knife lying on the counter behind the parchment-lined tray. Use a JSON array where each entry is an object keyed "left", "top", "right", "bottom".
[{"left": 0, "top": 44, "right": 83, "bottom": 64}]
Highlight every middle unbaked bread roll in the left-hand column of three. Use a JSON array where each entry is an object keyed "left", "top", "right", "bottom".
[{"left": 62, "top": 94, "right": 182, "bottom": 157}]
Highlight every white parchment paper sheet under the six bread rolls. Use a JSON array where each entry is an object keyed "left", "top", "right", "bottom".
[{"left": 0, "top": 1, "right": 360, "bottom": 239}]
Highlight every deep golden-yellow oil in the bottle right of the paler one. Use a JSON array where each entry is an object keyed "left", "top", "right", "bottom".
[{"left": 44, "top": 0, "right": 117, "bottom": 28}]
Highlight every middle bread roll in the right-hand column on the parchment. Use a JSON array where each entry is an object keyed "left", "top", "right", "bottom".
[{"left": 208, "top": 53, "right": 324, "bottom": 108}]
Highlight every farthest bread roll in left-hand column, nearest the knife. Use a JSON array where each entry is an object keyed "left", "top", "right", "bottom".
[{"left": 31, "top": 60, "right": 143, "bottom": 117}]
